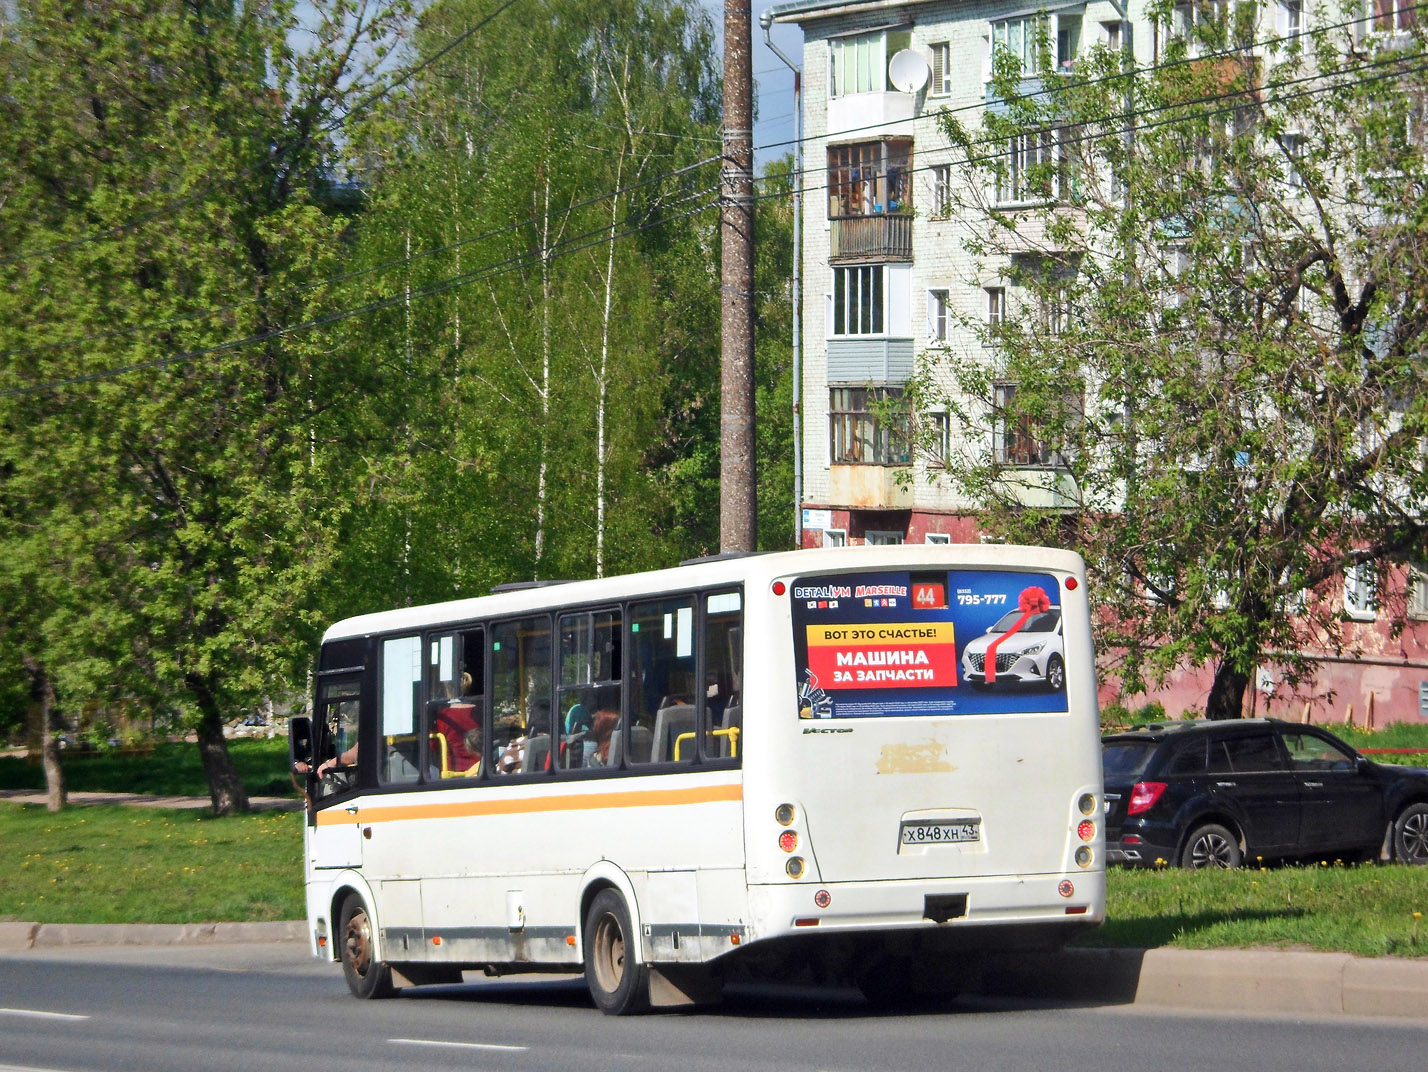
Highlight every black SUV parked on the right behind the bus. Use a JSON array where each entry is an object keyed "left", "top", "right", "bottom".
[{"left": 1101, "top": 718, "right": 1428, "bottom": 868}]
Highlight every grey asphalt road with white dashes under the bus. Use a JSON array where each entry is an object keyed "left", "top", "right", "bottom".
[{"left": 0, "top": 944, "right": 1428, "bottom": 1072}]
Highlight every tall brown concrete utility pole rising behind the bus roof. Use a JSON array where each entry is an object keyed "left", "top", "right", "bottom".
[{"left": 718, "top": 0, "right": 758, "bottom": 551}]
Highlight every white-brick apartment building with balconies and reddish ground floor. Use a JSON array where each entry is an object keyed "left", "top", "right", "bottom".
[{"left": 767, "top": 0, "right": 1428, "bottom": 722}]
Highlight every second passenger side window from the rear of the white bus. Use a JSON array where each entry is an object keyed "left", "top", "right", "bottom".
[{"left": 627, "top": 595, "right": 698, "bottom": 765}]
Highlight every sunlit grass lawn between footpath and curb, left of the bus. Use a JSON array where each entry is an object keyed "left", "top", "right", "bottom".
[{"left": 0, "top": 804, "right": 304, "bottom": 924}]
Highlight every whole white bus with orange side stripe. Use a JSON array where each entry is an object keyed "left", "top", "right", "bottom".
[{"left": 291, "top": 545, "right": 1105, "bottom": 1013}]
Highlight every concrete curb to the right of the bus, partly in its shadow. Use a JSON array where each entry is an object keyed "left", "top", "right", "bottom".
[{"left": 981, "top": 949, "right": 1428, "bottom": 1019}]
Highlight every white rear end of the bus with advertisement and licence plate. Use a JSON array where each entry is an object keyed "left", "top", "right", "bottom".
[{"left": 744, "top": 545, "right": 1105, "bottom": 991}]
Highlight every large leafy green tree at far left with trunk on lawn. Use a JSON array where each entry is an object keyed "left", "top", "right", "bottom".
[{"left": 0, "top": 0, "right": 407, "bottom": 812}]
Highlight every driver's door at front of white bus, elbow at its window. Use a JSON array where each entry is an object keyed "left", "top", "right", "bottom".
[{"left": 308, "top": 674, "right": 363, "bottom": 871}]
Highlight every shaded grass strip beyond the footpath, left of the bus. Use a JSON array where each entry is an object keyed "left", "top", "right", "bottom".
[{"left": 0, "top": 737, "right": 297, "bottom": 798}]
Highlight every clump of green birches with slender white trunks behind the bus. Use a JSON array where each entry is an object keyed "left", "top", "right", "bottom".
[{"left": 335, "top": 0, "right": 718, "bottom": 605}]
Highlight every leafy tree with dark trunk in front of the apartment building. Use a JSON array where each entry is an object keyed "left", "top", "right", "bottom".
[{"left": 920, "top": 4, "right": 1428, "bottom": 718}]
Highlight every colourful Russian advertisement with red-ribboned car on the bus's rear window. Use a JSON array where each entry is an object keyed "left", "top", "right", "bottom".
[{"left": 790, "top": 570, "right": 1067, "bottom": 719}]
